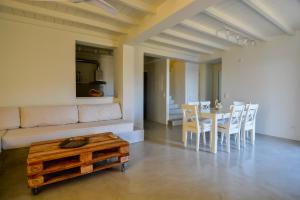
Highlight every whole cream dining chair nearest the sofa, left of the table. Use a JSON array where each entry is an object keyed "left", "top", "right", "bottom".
[{"left": 182, "top": 104, "right": 201, "bottom": 151}]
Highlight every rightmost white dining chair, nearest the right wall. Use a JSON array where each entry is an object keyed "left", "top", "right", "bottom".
[{"left": 241, "top": 104, "right": 259, "bottom": 146}]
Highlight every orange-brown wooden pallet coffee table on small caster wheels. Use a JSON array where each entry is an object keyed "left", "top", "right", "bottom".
[{"left": 27, "top": 133, "right": 129, "bottom": 194}]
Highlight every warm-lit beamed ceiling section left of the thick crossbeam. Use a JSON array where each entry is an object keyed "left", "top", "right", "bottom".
[{"left": 0, "top": 0, "right": 164, "bottom": 36}]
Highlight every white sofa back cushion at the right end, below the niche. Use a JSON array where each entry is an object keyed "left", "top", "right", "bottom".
[{"left": 78, "top": 103, "right": 122, "bottom": 122}]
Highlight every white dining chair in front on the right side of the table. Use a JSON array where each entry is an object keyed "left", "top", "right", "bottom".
[{"left": 218, "top": 105, "right": 245, "bottom": 152}]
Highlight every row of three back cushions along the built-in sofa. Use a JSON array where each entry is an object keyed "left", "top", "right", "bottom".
[{"left": 0, "top": 103, "right": 122, "bottom": 130}]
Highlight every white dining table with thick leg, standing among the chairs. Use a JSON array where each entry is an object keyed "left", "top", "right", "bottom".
[{"left": 199, "top": 108, "right": 231, "bottom": 153}]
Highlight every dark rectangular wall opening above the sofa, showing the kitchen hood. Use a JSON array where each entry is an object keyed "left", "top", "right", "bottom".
[{"left": 76, "top": 43, "right": 114, "bottom": 97}]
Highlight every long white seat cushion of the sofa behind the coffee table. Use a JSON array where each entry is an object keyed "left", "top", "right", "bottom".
[{"left": 2, "top": 119, "right": 133, "bottom": 149}]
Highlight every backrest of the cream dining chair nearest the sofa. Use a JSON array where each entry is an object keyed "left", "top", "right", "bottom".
[{"left": 181, "top": 104, "right": 200, "bottom": 130}]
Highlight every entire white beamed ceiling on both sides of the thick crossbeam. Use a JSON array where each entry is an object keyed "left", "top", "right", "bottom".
[{"left": 0, "top": 0, "right": 300, "bottom": 54}]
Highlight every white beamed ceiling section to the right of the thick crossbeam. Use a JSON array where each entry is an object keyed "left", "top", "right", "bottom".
[{"left": 142, "top": 0, "right": 300, "bottom": 53}]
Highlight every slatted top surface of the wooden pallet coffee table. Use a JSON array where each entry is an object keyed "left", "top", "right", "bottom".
[{"left": 27, "top": 133, "right": 129, "bottom": 164}]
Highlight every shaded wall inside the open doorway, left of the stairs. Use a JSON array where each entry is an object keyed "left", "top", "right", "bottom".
[{"left": 145, "top": 59, "right": 169, "bottom": 124}]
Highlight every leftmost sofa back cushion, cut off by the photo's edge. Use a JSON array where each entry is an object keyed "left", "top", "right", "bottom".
[{"left": 0, "top": 107, "right": 20, "bottom": 130}]
